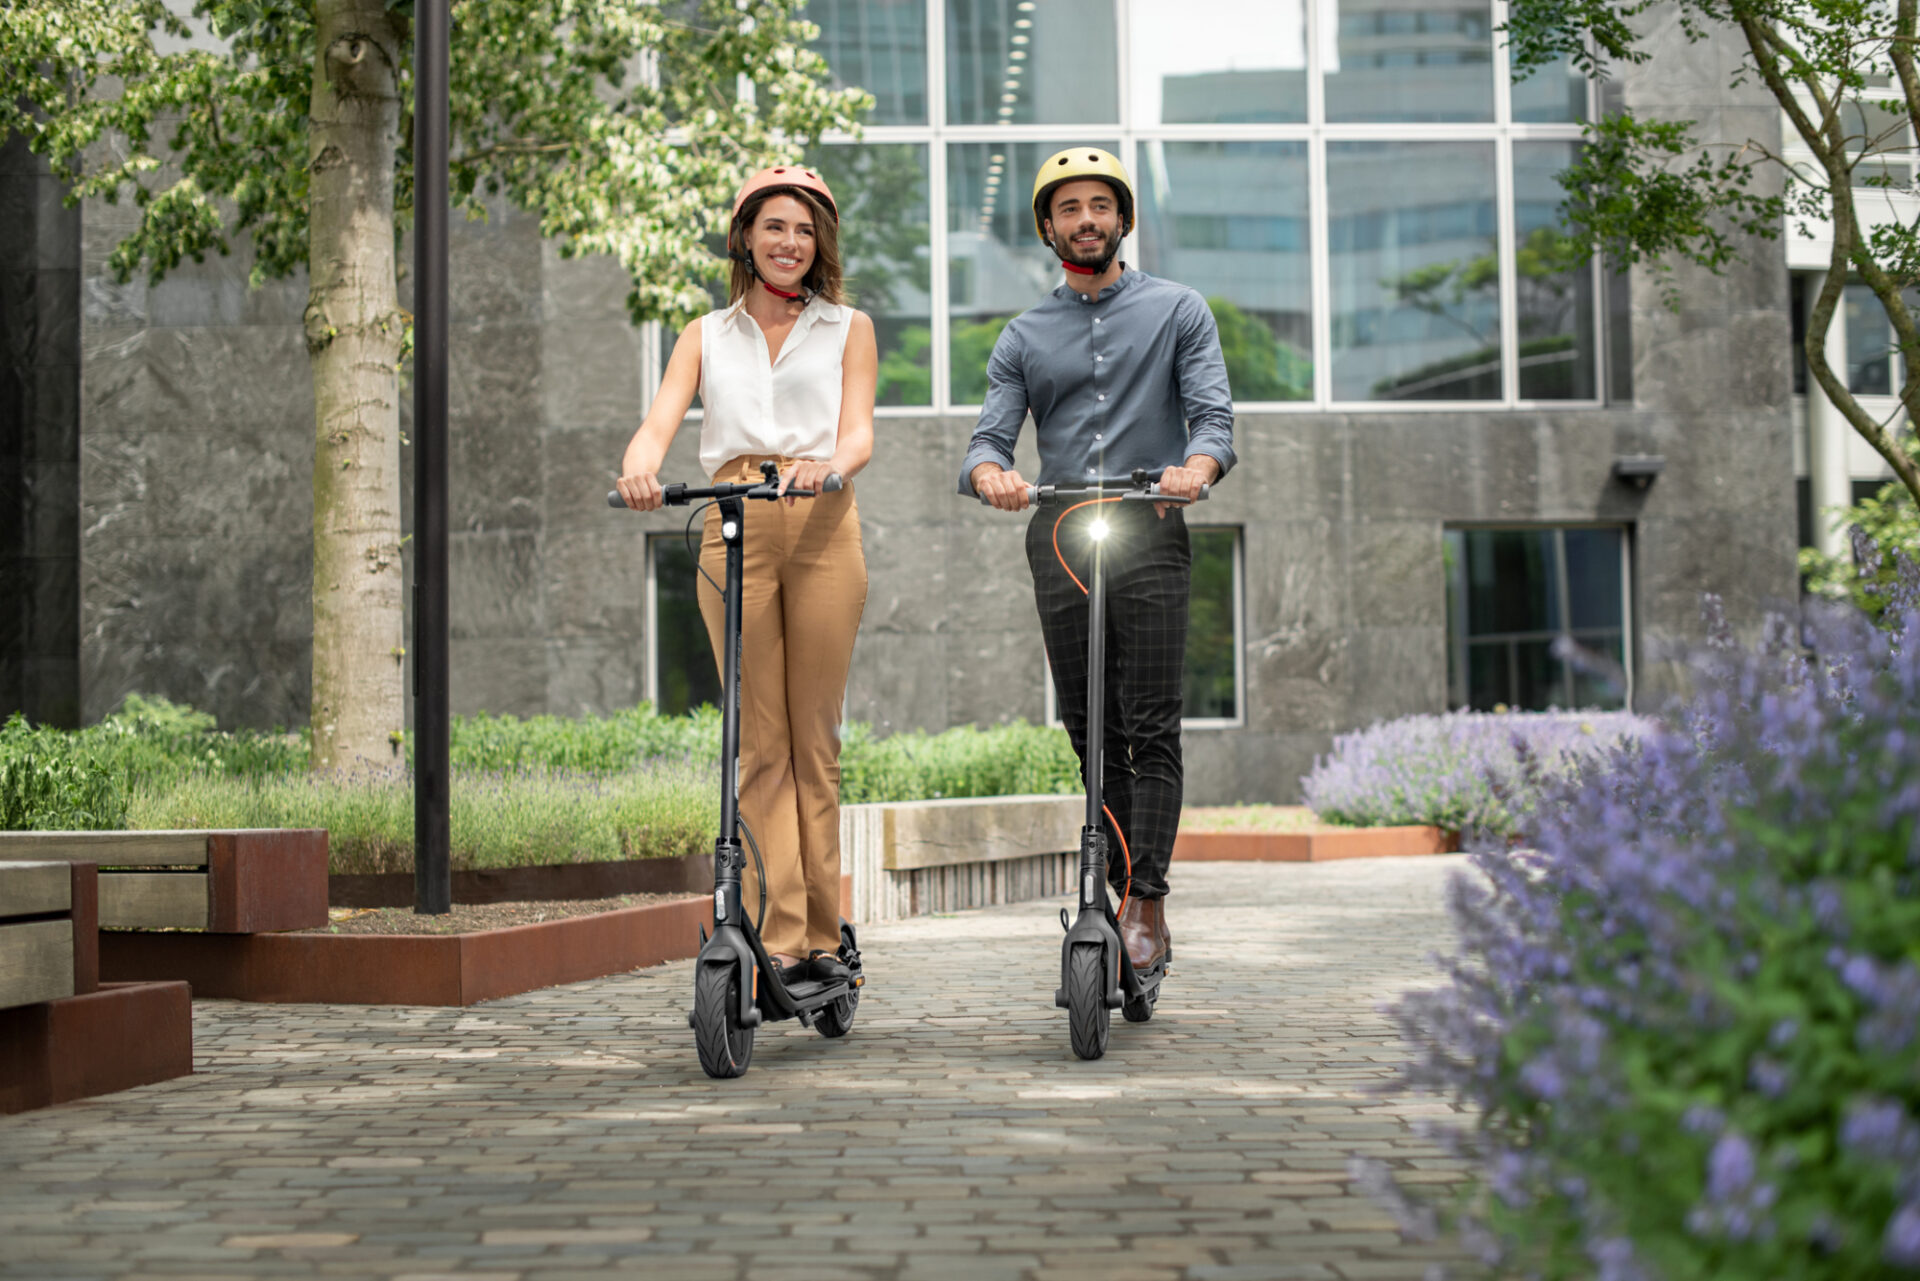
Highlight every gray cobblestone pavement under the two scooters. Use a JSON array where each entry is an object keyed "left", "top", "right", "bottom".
[{"left": 0, "top": 857, "right": 1461, "bottom": 1281}]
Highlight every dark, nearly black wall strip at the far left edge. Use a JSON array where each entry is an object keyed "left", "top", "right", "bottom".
[{"left": 0, "top": 136, "right": 81, "bottom": 726}]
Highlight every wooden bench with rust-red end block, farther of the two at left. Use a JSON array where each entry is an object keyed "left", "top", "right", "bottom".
[{"left": 0, "top": 830, "right": 326, "bottom": 933}]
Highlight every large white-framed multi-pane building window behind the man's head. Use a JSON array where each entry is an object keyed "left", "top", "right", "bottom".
[{"left": 698, "top": 0, "right": 1597, "bottom": 415}]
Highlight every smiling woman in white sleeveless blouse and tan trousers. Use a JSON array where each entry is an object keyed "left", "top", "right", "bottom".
[{"left": 620, "top": 165, "right": 879, "bottom": 981}]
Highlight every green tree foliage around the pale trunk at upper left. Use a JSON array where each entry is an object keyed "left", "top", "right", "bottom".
[{"left": 0, "top": 0, "right": 872, "bottom": 321}]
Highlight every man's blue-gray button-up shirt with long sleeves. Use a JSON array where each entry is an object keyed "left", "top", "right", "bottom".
[{"left": 960, "top": 271, "right": 1235, "bottom": 494}]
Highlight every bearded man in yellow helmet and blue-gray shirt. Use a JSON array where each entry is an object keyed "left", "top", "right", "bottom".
[{"left": 960, "top": 146, "right": 1235, "bottom": 970}]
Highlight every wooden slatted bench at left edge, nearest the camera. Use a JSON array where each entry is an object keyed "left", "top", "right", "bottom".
[{"left": 0, "top": 862, "right": 100, "bottom": 1010}]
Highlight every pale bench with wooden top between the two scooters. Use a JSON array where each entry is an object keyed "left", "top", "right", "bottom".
[{"left": 841, "top": 795, "right": 1087, "bottom": 922}]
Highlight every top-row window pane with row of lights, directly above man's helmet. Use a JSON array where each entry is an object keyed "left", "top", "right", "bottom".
[{"left": 947, "top": 0, "right": 1119, "bottom": 126}]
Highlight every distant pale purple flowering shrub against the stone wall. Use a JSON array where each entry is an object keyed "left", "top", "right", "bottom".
[{"left": 1300, "top": 713, "right": 1647, "bottom": 839}]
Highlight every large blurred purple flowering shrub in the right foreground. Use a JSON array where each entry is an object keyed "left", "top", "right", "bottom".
[{"left": 1373, "top": 590, "right": 1920, "bottom": 1281}]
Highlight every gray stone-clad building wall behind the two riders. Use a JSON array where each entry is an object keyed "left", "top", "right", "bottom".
[{"left": 60, "top": 12, "right": 1795, "bottom": 801}]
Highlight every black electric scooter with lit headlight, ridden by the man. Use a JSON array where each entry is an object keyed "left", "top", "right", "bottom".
[{"left": 981, "top": 469, "right": 1208, "bottom": 1058}]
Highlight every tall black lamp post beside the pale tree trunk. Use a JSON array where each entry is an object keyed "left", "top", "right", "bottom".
[{"left": 413, "top": 0, "right": 453, "bottom": 914}]
